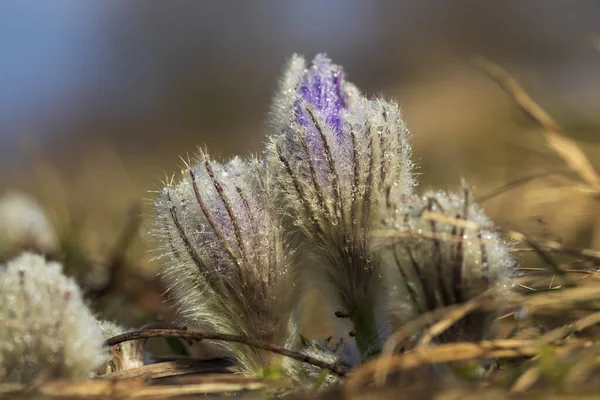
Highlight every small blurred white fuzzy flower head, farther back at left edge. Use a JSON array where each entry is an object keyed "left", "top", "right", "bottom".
[{"left": 0, "top": 192, "right": 58, "bottom": 259}]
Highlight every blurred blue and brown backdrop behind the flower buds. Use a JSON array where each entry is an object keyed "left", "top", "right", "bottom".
[{"left": 0, "top": 0, "right": 600, "bottom": 294}]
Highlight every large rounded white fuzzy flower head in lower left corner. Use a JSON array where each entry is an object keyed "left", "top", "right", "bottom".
[{"left": 0, "top": 253, "right": 108, "bottom": 383}]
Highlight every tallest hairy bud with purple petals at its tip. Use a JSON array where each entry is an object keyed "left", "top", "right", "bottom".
[{"left": 266, "top": 55, "right": 413, "bottom": 359}]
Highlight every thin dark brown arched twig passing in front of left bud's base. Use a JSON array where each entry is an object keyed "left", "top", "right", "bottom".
[{"left": 105, "top": 329, "right": 346, "bottom": 377}]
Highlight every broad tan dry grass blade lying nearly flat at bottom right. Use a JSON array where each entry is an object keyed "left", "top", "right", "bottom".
[{"left": 346, "top": 339, "right": 592, "bottom": 391}]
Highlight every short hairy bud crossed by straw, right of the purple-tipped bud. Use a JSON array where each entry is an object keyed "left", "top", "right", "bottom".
[{"left": 375, "top": 188, "right": 514, "bottom": 341}]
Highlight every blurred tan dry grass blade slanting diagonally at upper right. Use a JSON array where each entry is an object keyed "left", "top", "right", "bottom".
[{"left": 473, "top": 56, "right": 600, "bottom": 194}]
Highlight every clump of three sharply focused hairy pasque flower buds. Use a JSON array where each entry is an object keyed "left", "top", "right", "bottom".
[{"left": 156, "top": 55, "right": 513, "bottom": 384}]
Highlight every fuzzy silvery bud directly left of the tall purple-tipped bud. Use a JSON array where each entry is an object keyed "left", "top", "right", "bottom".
[{"left": 156, "top": 151, "right": 295, "bottom": 374}]
